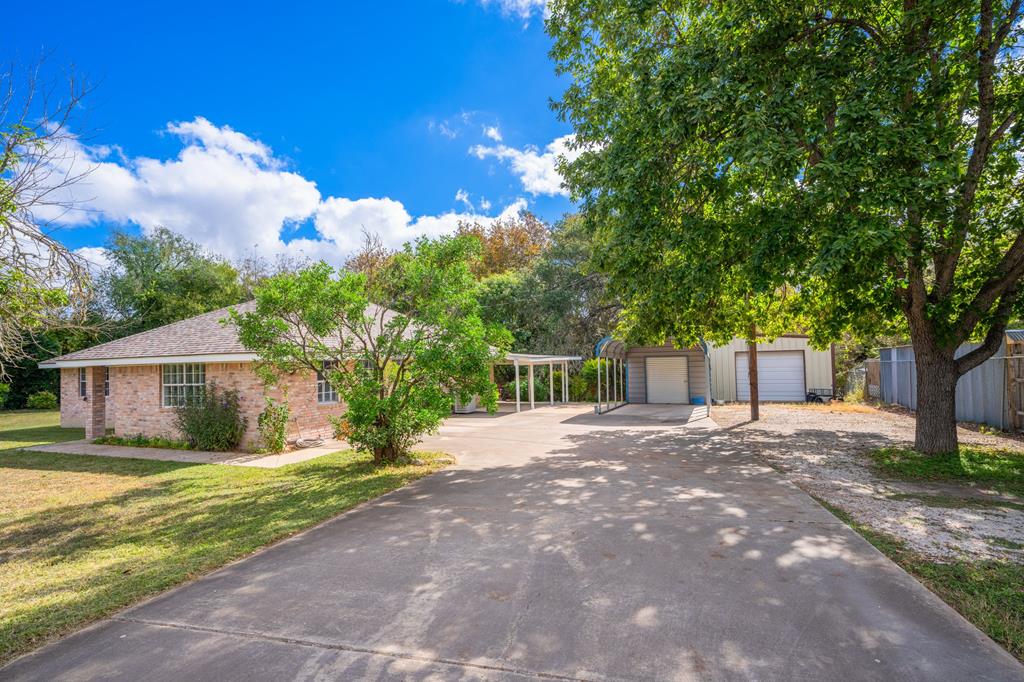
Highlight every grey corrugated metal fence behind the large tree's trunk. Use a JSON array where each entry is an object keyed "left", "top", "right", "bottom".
[{"left": 879, "top": 341, "right": 1011, "bottom": 429}]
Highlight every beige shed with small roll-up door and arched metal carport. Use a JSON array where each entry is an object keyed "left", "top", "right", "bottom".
[{"left": 594, "top": 337, "right": 711, "bottom": 419}]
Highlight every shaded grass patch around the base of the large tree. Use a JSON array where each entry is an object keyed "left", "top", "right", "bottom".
[{"left": 870, "top": 445, "right": 1024, "bottom": 495}]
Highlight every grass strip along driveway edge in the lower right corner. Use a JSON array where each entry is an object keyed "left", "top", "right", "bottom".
[{"left": 818, "top": 499, "right": 1024, "bottom": 662}]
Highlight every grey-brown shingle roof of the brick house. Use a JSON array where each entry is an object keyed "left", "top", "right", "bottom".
[{"left": 43, "top": 301, "right": 256, "bottom": 365}]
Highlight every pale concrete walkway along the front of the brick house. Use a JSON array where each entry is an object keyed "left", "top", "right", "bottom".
[{"left": 22, "top": 440, "right": 348, "bottom": 469}]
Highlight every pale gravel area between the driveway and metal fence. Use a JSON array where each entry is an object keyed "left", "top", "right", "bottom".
[{"left": 712, "top": 404, "right": 1024, "bottom": 562}]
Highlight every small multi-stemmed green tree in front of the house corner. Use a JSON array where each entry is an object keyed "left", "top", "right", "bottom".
[{"left": 231, "top": 233, "right": 508, "bottom": 464}]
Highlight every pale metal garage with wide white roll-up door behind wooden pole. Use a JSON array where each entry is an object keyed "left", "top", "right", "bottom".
[{"left": 709, "top": 335, "right": 836, "bottom": 402}]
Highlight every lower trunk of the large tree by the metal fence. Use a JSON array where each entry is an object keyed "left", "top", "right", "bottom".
[{"left": 913, "top": 343, "right": 959, "bottom": 455}]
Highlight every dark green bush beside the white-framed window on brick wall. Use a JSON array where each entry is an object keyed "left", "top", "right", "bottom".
[{"left": 174, "top": 382, "right": 249, "bottom": 452}]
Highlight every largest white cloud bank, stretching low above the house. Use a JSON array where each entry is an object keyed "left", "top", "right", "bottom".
[{"left": 44, "top": 117, "right": 525, "bottom": 263}]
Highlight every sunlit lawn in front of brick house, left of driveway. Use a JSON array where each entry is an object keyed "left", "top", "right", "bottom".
[{"left": 0, "top": 412, "right": 446, "bottom": 663}]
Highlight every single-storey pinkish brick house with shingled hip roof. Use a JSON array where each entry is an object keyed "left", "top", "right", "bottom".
[{"left": 39, "top": 302, "right": 345, "bottom": 449}]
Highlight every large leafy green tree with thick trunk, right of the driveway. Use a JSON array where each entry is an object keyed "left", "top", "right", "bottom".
[{"left": 548, "top": 0, "right": 1024, "bottom": 453}]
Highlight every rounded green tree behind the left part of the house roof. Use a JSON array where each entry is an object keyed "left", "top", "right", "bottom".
[{"left": 100, "top": 227, "right": 248, "bottom": 334}]
